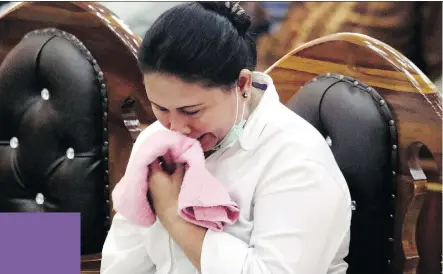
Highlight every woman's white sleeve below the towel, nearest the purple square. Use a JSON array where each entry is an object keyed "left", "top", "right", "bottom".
[{"left": 100, "top": 213, "right": 155, "bottom": 274}]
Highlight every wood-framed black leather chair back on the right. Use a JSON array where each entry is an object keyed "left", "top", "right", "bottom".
[{"left": 267, "top": 33, "right": 442, "bottom": 274}]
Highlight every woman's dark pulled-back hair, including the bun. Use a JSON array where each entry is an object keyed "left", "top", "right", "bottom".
[{"left": 139, "top": 2, "right": 257, "bottom": 88}]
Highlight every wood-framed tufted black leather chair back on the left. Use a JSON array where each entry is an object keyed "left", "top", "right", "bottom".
[{"left": 0, "top": 2, "right": 154, "bottom": 268}]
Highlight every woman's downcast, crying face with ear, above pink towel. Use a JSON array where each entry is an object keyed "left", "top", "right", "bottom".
[{"left": 144, "top": 70, "right": 252, "bottom": 152}]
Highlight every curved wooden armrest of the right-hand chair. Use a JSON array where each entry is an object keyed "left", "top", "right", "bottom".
[{"left": 399, "top": 142, "right": 441, "bottom": 274}]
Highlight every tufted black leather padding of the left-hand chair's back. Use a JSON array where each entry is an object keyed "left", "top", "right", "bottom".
[{"left": 0, "top": 29, "right": 109, "bottom": 254}]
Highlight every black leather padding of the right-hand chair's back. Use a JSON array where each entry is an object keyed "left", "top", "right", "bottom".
[{"left": 287, "top": 74, "right": 397, "bottom": 274}]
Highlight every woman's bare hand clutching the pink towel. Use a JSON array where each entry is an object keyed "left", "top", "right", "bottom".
[{"left": 148, "top": 160, "right": 185, "bottom": 223}]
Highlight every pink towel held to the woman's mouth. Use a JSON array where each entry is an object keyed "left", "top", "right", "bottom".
[{"left": 112, "top": 131, "right": 239, "bottom": 231}]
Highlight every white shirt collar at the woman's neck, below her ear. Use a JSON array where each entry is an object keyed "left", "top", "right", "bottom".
[{"left": 239, "top": 72, "right": 280, "bottom": 150}]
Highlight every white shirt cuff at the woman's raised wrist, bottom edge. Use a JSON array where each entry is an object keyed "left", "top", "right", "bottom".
[{"left": 200, "top": 229, "right": 249, "bottom": 274}]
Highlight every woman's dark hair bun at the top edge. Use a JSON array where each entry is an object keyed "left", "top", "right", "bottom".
[{"left": 199, "top": 1, "right": 251, "bottom": 35}]
